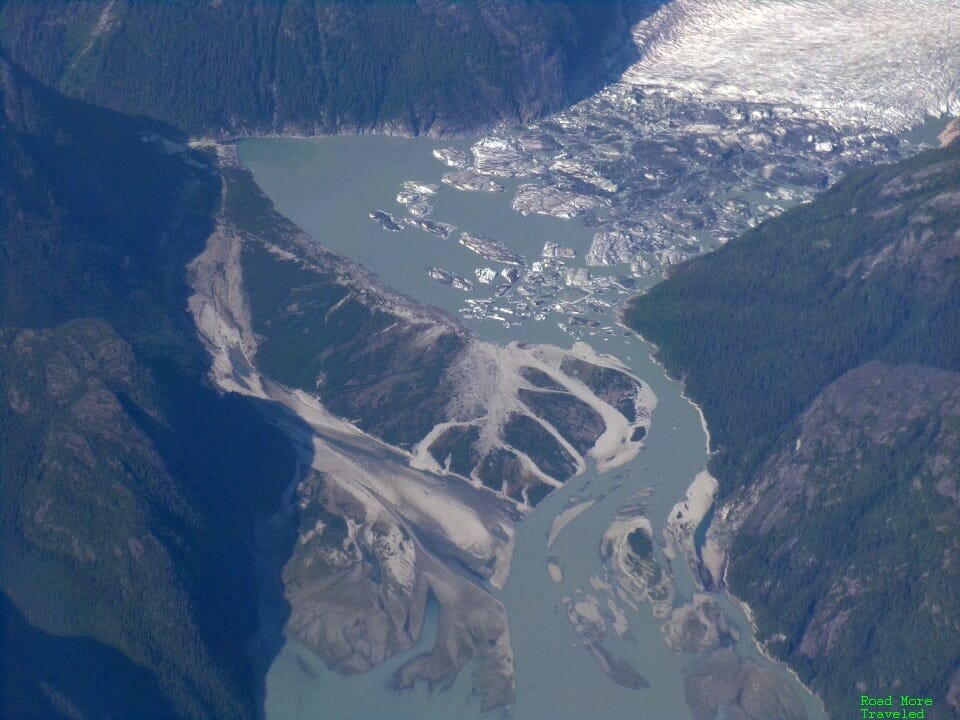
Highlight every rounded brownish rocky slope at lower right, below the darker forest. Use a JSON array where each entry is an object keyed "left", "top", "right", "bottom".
[{"left": 720, "top": 361, "right": 960, "bottom": 718}]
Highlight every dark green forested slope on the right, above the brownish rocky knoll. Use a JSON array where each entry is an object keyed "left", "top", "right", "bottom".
[{"left": 624, "top": 144, "right": 960, "bottom": 497}]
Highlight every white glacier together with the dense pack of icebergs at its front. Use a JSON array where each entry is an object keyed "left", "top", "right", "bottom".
[{"left": 448, "top": 0, "right": 960, "bottom": 282}]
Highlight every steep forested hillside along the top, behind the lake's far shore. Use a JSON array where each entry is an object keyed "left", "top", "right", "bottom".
[{"left": 0, "top": 0, "right": 656, "bottom": 135}]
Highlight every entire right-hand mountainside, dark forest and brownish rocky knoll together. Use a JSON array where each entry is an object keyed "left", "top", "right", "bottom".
[{"left": 625, "top": 142, "right": 960, "bottom": 718}]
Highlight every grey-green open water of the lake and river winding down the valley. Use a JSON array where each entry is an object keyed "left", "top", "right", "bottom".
[{"left": 239, "top": 136, "right": 824, "bottom": 720}]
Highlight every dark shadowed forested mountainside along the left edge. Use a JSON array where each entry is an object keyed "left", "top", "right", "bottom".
[{"left": 0, "top": 58, "right": 294, "bottom": 718}]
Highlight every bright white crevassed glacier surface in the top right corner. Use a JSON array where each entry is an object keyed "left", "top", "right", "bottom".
[{"left": 622, "top": 0, "right": 960, "bottom": 132}]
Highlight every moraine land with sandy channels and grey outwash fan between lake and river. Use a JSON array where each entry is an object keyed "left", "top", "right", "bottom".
[{"left": 181, "top": 153, "right": 656, "bottom": 709}]
